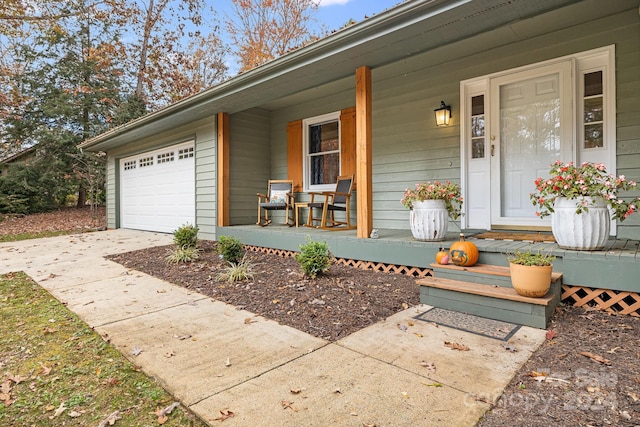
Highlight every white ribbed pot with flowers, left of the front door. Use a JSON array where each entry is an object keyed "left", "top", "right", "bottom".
[{"left": 400, "top": 181, "right": 462, "bottom": 241}]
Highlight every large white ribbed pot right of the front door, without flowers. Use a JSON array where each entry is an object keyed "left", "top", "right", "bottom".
[{"left": 551, "top": 197, "right": 611, "bottom": 251}]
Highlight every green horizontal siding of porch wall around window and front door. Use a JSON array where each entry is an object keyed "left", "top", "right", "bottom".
[{"left": 258, "top": 5, "right": 640, "bottom": 239}]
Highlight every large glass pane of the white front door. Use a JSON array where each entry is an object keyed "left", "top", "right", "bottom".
[{"left": 499, "top": 73, "right": 562, "bottom": 218}]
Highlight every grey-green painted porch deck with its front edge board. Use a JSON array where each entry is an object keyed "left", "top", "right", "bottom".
[{"left": 218, "top": 224, "right": 640, "bottom": 300}]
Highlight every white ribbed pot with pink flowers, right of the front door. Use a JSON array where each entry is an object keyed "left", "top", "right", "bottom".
[{"left": 530, "top": 160, "right": 640, "bottom": 250}]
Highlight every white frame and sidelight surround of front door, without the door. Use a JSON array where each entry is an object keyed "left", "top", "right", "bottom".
[{"left": 460, "top": 45, "right": 617, "bottom": 235}]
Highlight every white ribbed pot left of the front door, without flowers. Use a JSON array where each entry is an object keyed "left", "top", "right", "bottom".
[{"left": 409, "top": 200, "right": 449, "bottom": 242}]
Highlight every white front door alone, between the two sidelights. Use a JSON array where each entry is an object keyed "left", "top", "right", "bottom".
[{"left": 489, "top": 61, "right": 575, "bottom": 228}]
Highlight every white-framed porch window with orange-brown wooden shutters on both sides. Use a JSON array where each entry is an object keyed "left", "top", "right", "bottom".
[{"left": 287, "top": 108, "right": 356, "bottom": 192}]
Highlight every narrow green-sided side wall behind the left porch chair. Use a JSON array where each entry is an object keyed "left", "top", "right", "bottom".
[{"left": 229, "top": 108, "right": 272, "bottom": 225}]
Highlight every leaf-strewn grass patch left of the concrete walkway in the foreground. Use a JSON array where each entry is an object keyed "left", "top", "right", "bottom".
[{"left": 0, "top": 273, "right": 205, "bottom": 427}]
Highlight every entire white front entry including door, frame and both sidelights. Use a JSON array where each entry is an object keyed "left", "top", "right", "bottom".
[{"left": 460, "top": 46, "right": 616, "bottom": 232}]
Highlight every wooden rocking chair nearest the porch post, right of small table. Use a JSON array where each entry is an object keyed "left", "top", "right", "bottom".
[{"left": 307, "top": 175, "right": 356, "bottom": 230}]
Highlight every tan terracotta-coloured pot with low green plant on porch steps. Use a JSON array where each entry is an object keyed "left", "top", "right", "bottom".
[{"left": 507, "top": 251, "right": 555, "bottom": 298}]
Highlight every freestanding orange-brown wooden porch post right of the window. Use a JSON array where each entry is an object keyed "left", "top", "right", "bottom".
[{"left": 356, "top": 66, "right": 373, "bottom": 238}]
